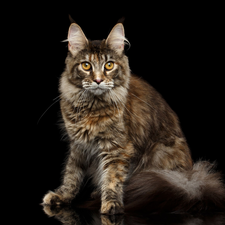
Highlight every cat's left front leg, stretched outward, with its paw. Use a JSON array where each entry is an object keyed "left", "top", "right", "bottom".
[{"left": 43, "top": 144, "right": 84, "bottom": 205}]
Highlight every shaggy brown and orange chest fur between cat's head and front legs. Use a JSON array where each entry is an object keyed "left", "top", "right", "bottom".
[{"left": 61, "top": 99, "right": 126, "bottom": 149}]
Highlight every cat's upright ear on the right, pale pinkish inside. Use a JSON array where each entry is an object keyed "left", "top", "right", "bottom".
[{"left": 106, "top": 23, "right": 128, "bottom": 54}]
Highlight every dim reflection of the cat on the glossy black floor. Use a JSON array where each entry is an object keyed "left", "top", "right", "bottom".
[{"left": 43, "top": 206, "right": 225, "bottom": 225}]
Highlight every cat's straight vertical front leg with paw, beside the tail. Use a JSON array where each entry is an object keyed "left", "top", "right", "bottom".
[{"left": 101, "top": 144, "right": 133, "bottom": 215}]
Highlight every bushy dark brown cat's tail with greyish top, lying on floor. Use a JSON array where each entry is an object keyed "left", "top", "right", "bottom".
[{"left": 124, "top": 161, "right": 225, "bottom": 212}]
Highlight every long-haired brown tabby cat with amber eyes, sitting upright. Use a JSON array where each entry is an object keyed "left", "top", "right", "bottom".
[{"left": 43, "top": 23, "right": 225, "bottom": 215}]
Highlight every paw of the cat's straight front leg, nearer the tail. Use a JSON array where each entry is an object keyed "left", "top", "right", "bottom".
[{"left": 101, "top": 201, "right": 124, "bottom": 215}]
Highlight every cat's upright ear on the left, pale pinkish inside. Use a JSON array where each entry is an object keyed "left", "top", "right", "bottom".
[{"left": 67, "top": 23, "right": 88, "bottom": 55}]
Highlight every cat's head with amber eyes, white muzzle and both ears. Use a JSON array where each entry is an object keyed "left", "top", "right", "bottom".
[{"left": 60, "top": 23, "right": 130, "bottom": 96}]
